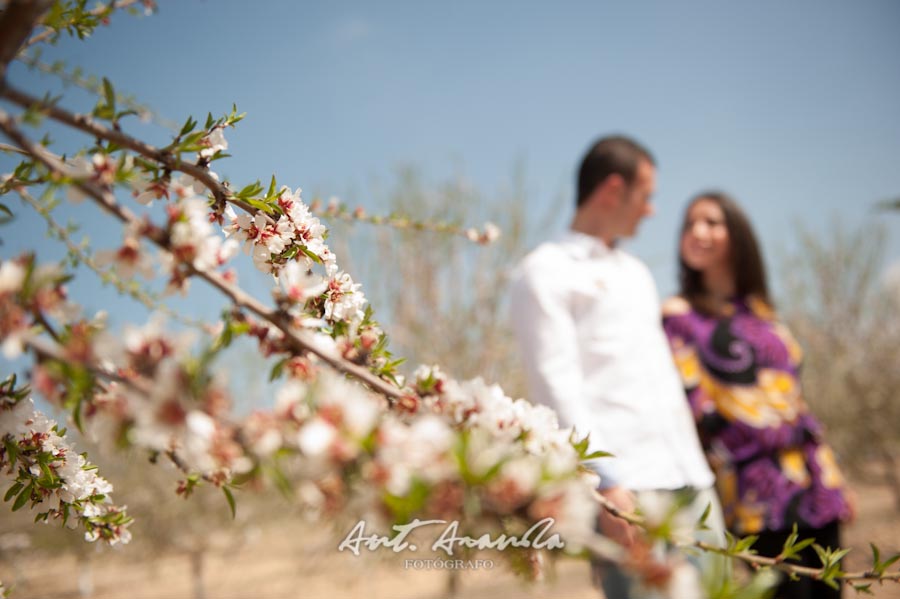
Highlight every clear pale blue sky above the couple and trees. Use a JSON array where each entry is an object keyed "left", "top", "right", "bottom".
[{"left": 0, "top": 0, "right": 900, "bottom": 324}]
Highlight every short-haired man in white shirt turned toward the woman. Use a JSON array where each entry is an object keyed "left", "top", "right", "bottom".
[{"left": 511, "top": 136, "right": 722, "bottom": 599}]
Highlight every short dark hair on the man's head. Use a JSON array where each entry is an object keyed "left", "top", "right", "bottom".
[{"left": 577, "top": 135, "right": 656, "bottom": 206}]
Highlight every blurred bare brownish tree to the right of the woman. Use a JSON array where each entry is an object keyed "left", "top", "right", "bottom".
[{"left": 782, "top": 221, "right": 900, "bottom": 511}]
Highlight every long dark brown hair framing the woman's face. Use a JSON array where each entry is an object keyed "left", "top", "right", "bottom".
[{"left": 678, "top": 191, "right": 772, "bottom": 313}]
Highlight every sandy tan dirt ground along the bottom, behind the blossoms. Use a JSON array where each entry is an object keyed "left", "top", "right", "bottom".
[{"left": 0, "top": 478, "right": 900, "bottom": 599}]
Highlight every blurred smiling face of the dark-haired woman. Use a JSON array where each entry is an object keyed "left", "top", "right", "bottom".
[{"left": 681, "top": 198, "right": 730, "bottom": 272}]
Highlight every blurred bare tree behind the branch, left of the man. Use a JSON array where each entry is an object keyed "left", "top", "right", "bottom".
[{"left": 329, "top": 163, "right": 568, "bottom": 398}]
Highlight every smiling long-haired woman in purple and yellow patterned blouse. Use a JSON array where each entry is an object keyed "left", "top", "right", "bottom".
[{"left": 663, "top": 192, "right": 851, "bottom": 599}]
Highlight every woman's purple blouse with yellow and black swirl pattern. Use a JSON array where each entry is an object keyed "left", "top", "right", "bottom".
[{"left": 663, "top": 298, "right": 848, "bottom": 535}]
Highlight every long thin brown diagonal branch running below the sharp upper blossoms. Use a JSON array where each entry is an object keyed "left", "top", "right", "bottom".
[{"left": 0, "top": 110, "right": 405, "bottom": 400}]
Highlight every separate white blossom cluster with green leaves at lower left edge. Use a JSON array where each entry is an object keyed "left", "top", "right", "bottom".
[{"left": 0, "top": 399, "right": 131, "bottom": 545}]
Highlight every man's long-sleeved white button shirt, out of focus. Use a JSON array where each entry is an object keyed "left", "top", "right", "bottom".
[{"left": 510, "top": 231, "right": 713, "bottom": 490}]
